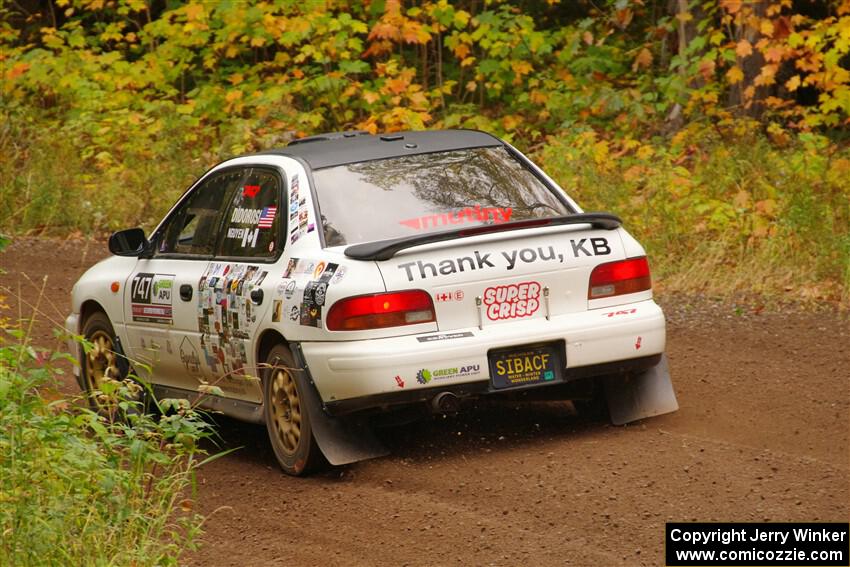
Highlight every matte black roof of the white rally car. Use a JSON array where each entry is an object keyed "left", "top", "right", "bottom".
[{"left": 259, "top": 130, "right": 504, "bottom": 169}]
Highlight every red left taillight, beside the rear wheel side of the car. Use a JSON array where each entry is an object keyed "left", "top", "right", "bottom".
[{"left": 327, "top": 289, "right": 437, "bottom": 331}]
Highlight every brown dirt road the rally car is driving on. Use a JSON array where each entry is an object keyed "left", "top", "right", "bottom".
[{"left": 0, "top": 240, "right": 850, "bottom": 567}]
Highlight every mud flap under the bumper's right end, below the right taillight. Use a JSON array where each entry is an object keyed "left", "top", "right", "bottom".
[{"left": 604, "top": 354, "right": 679, "bottom": 425}]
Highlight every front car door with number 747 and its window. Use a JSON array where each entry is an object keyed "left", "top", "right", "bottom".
[{"left": 124, "top": 169, "right": 244, "bottom": 390}]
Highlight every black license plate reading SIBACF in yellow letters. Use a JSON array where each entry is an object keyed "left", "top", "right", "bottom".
[{"left": 488, "top": 344, "right": 564, "bottom": 390}]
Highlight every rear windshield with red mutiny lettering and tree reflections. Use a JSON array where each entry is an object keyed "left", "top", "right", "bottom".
[{"left": 313, "top": 147, "right": 570, "bottom": 246}]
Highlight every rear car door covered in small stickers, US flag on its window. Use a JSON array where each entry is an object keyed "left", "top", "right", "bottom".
[{"left": 193, "top": 166, "right": 286, "bottom": 402}]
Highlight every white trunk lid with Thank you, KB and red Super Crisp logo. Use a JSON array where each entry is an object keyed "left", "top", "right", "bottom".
[{"left": 377, "top": 225, "right": 625, "bottom": 331}]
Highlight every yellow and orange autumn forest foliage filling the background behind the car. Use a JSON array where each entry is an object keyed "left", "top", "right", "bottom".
[{"left": 0, "top": 0, "right": 850, "bottom": 306}]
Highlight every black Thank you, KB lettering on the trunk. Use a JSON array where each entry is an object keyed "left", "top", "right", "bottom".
[{"left": 397, "top": 238, "right": 611, "bottom": 282}]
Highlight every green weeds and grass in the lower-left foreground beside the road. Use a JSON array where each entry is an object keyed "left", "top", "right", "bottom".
[{"left": 0, "top": 330, "right": 210, "bottom": 566}]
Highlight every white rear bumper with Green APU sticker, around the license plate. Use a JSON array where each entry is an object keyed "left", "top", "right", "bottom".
[{"left": 300, "top": 300, "right": 666, "bottom": 413}]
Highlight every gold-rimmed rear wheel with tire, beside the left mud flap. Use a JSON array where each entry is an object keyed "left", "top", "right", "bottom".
[{"left": 263, "top": 345, "right": 322, "bottom": 476}]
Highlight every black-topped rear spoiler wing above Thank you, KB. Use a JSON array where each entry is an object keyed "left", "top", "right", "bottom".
[{"left": 345, "top": 213, "right": 623, "bottom": 260}]
